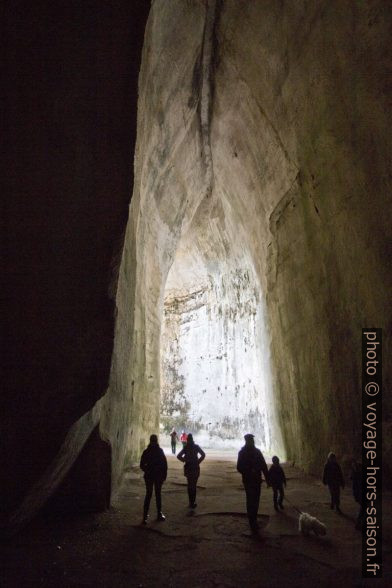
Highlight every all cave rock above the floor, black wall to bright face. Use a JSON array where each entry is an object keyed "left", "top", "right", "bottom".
[{"left": 1, "top": 0, "right": 392, "bottom": 527}]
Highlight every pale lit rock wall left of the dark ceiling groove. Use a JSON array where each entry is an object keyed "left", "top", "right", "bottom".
[{"left": 102, "top": 2, "right": 210, "bottom": 490}]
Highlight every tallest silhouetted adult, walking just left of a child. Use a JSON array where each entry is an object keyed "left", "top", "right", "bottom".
[{"left": 237, "top": 433, "right": 269, "bottom": 533}]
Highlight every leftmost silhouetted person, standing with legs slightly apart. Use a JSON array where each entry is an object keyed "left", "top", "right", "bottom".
[{"left": 140, "top": 435, "right": 167, "bottom": 525}]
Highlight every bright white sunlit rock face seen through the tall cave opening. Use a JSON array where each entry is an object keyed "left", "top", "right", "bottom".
[{"left": 161, "top": 229, "right": 282, "bottom": 454}]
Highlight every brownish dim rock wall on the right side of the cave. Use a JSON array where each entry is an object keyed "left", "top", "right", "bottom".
[{"left": 211, "top": 2, "right": 391, "bottom": 472}]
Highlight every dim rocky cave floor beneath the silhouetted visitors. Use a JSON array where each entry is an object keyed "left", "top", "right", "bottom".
[{"left": 1, "top": 451, "right": 392, "bottom": 588}]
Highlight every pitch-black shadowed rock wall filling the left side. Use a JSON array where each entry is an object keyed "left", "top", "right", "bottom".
[{"left": 0, "top": 0, "right": 150, "bottom": 520}]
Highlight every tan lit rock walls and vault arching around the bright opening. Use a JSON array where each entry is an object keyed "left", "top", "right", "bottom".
[{"left": 108, "top": 0, "right": 391, "bottom": 486}]
